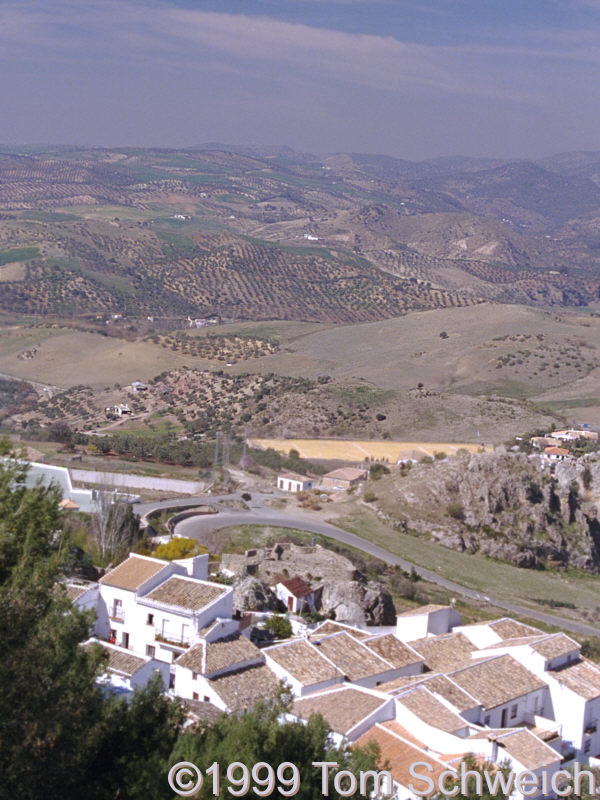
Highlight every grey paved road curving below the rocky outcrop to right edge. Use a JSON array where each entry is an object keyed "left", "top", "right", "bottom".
[{"left": 169, "top": 495, "right": 600, "bottom": 637}]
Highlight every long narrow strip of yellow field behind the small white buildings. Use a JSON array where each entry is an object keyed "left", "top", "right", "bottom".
[{"left": 248, "top": 439, "right": 493, "bottom": 464}]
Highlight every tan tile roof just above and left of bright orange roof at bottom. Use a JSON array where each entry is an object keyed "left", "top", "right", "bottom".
[{"left": 292, "top": 687, "right": 391, "bottom": 735}]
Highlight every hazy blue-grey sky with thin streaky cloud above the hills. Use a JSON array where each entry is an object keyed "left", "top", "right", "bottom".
[{"left": 0, "top": 0, "right": 600, "bottom": 158}]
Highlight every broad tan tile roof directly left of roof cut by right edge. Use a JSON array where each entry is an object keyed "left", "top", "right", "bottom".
[{"left": 449, "top": 655, "right": 546, "bottom": 709}]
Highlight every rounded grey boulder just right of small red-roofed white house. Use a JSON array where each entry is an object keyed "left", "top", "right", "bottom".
[{"left": 320, "top": 581, "right": 396, "bottom": 625}]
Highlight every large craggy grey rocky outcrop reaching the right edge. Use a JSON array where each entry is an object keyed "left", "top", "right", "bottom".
[{"left": 378, "top": 452, "right": 600, "bottom": 572}]
